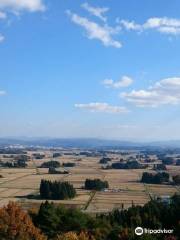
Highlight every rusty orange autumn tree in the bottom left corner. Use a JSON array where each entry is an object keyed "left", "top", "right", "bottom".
[{"left": 0, "top": 202, "right": 47, "bottom": 240}]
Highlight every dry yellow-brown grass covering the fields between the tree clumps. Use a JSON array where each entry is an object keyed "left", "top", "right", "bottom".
[{"left": 0, "top": 151, "right": 180, "bottom": 212}]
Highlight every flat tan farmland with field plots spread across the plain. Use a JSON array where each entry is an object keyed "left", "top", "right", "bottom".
[{"left": 0, "top": 149, "right": 180, "bottom": 213}]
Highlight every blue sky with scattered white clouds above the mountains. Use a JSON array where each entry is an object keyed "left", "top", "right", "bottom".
[{"left": 0, "top": 0, "right": 180, "bottom": 141}]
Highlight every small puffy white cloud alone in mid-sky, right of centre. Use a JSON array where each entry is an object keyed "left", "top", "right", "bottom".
[{"left": 102, "top": 76, "right": 133, "bottom": 88}]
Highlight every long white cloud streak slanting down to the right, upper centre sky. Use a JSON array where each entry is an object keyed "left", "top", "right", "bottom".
[{"left": 67, "top": 11, "right": 122, "bottom": 48}]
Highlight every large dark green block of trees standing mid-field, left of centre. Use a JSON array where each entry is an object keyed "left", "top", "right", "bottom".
[{"left": 40, "top": 180, "right": 76, "bottom": 200}]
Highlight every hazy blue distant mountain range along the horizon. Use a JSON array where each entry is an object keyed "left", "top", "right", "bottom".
[{"left": 0, "top": 138, "right": 180, "bottom": 149}]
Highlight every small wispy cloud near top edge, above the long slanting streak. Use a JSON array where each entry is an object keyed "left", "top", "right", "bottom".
[{"left": 81, "top": 3, "right": 109, "bottom": 22}]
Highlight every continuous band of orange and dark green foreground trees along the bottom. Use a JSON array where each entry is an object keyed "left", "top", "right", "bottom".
[{"left": 0, "top": 195, "right": 180, "bottom": 240}]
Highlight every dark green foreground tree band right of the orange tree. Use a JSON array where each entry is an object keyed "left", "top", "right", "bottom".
[{"left": 33, "top": 194, "right": 180, "bottom": 240}]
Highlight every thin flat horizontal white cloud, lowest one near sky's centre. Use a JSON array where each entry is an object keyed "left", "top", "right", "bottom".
[{"left": 75, "top": 102, "right": 129, "bottom": 113}]
